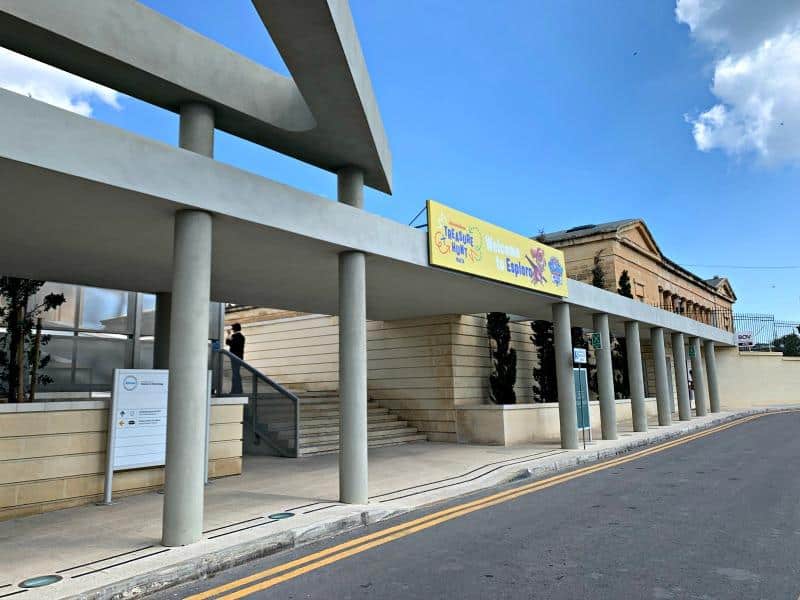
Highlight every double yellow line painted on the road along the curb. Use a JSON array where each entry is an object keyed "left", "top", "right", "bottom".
[{"left": 187, "top": 411, "right": 780, "bottom": 600}]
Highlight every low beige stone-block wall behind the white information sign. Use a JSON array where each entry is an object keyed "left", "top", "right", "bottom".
[{"left": 0, "top": 401, "right": 243, "bottom": 520}]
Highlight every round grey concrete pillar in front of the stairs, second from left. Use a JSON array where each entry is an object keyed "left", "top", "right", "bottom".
[{"left": 337, "top": 168, "right": 369, "bottom": 504}]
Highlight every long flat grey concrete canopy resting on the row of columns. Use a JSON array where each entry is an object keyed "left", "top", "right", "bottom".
[{"left": 0, "top": 91, "right": 733, "bottom": 344}]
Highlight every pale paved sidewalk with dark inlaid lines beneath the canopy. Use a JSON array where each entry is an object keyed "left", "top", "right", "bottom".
[{"left": 0, "top": 411, "right": 763, "bottom": 600}]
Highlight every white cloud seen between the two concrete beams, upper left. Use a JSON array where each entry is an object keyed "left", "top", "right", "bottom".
[{"left": 0, "top": 47, "right": 120, "bottom": 117}]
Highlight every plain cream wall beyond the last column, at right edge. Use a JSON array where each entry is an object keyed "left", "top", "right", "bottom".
[{"left": 716, "top": 348, "right": 800, "bottom": 409}]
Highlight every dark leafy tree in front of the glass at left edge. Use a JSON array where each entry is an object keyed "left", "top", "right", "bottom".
[{"left": 0, "top": 277, "right": 66, "bottom": 402}]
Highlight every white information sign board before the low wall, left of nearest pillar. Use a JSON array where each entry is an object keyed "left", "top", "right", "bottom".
[{"left": 110, "top": 369, "right": 169, "bottom": 471}]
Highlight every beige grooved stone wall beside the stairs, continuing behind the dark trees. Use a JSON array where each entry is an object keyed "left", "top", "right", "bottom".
[{"left": 231, "top": 308, "right": 535, "bottom": 442}]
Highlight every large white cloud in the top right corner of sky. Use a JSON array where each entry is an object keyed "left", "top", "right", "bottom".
[{"left": 675, "top": 0, "right": 800, "bottom": 164}]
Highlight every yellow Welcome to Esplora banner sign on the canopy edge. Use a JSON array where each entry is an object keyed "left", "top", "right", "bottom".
[{"left": 428, "top": 200, "right": 567, "bottom": 296}]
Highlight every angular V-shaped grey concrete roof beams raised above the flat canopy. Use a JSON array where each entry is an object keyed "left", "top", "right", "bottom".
[{"left": 0, "top": 0, "right": 392, "bottom": 193}]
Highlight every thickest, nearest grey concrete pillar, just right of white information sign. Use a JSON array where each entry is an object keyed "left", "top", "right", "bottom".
[{"left": 162, "top": 104, "right": 214, "bottom": 546}]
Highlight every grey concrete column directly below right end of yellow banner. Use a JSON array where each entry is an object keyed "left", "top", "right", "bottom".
[{"left": 553, "top": 302, "right": 578, "bottom": 449}]
